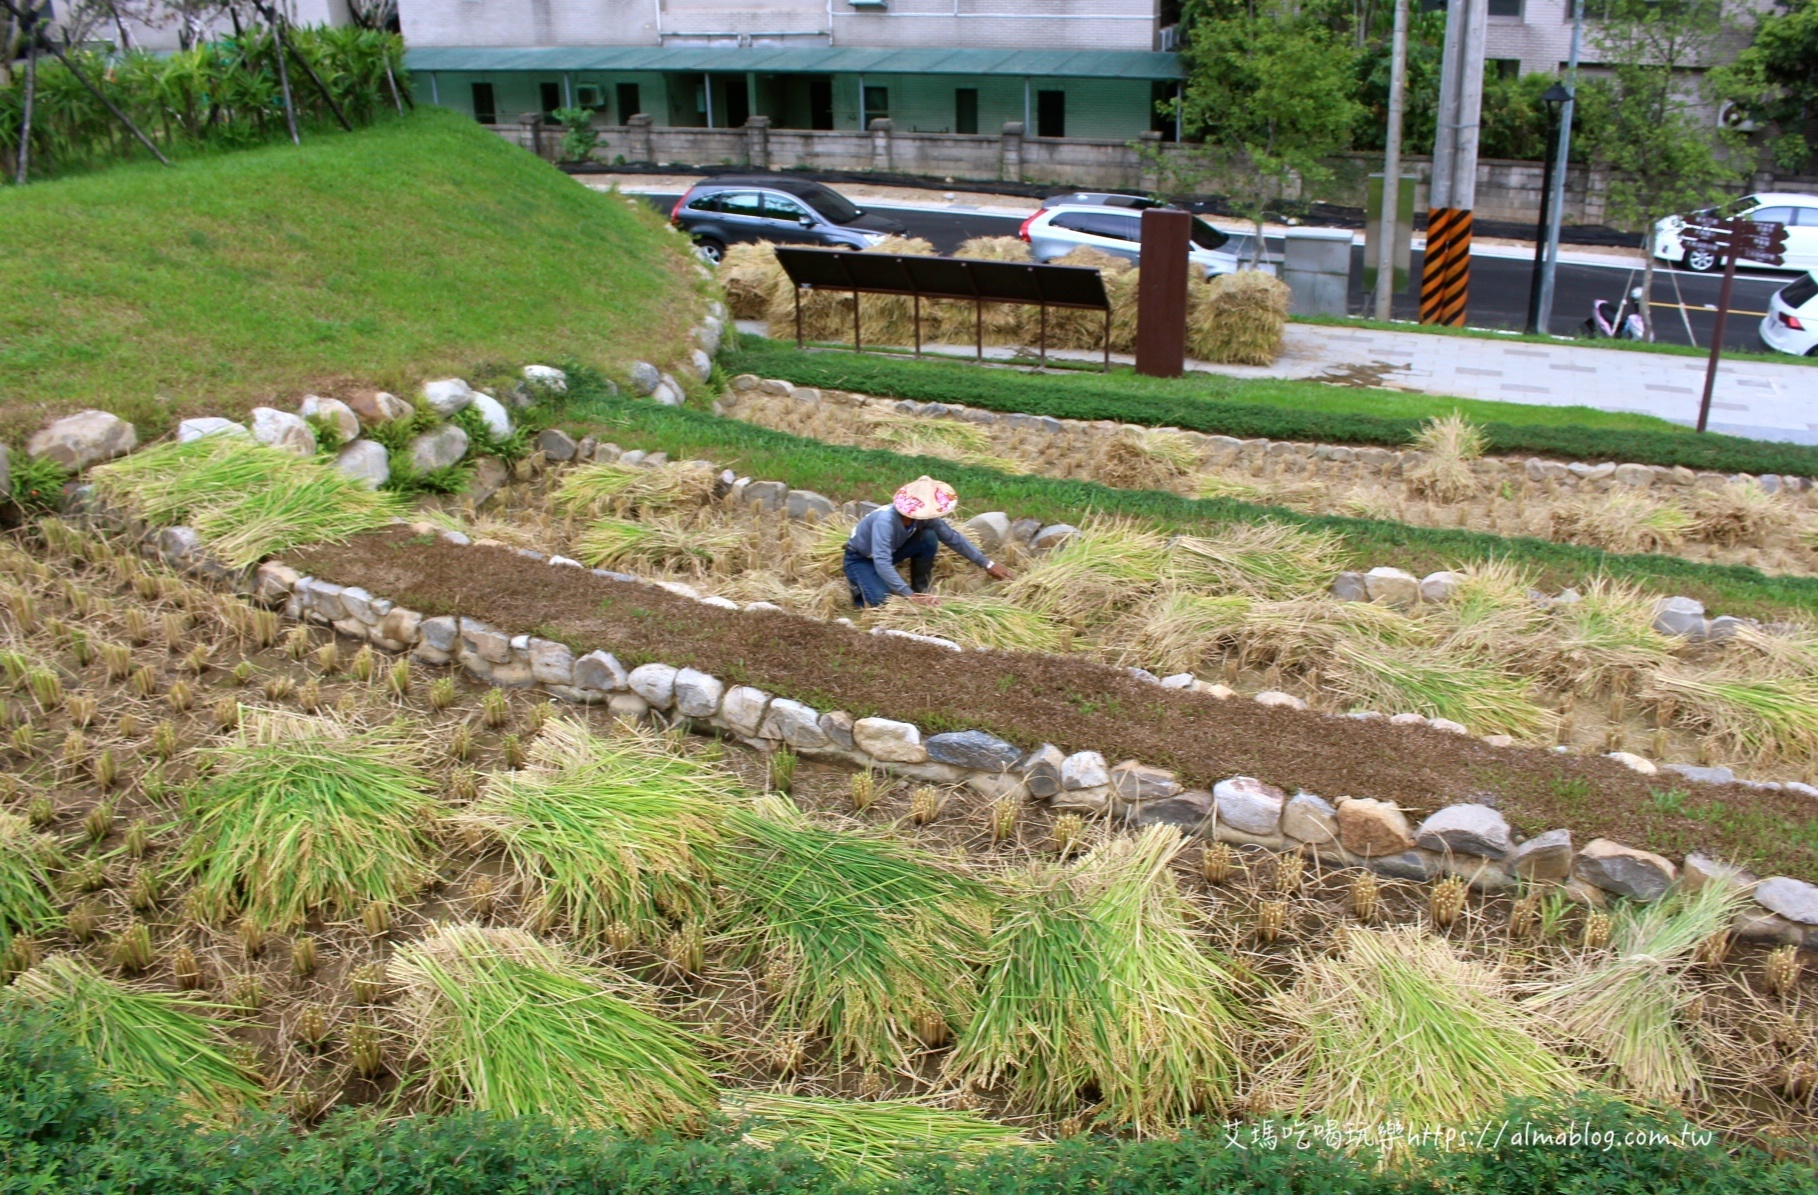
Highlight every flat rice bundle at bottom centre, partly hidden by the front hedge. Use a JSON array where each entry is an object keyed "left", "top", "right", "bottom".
[{"left": 720, "top": 1091, "right": 1024, "bottom": 1179}]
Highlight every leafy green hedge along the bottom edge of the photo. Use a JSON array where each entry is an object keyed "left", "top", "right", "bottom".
[{"left": 0, "top": 1004, "right": 1813, "bottom": 1195}]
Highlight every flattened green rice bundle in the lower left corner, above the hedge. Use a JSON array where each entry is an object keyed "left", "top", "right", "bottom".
[{"left": 7, "top": 955, "right": 264, "bottom": 1111}]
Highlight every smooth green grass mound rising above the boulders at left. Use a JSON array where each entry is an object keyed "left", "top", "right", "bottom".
[{"left": 0, "top": 109, "right": 700, "bottom": 438}]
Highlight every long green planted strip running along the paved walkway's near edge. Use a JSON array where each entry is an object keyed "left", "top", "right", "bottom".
[{"left": 720, "top": 336, "right": 1818, "bottom": 477}]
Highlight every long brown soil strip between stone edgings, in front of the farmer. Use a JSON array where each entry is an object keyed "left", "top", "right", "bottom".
[{"left": 287, "top": 527, "right": 1818, "bottom": 877}]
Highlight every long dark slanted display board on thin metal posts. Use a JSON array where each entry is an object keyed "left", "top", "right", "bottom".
[{"left": 776, "top": 246, "right": 1111, "bottom": 373}]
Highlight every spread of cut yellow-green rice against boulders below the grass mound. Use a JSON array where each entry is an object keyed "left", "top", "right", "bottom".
[{"left": 91, "top": 437, "right": 404, "bottom": 567}]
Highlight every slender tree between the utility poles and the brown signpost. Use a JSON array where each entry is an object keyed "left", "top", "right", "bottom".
[{"left": 1582, "top": 0, "right": 1738, "bottom": 340}]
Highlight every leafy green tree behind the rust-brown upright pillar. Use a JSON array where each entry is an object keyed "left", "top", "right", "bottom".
[{"left": 1171, "top": 0, "right": 1362, "bottom": 262}]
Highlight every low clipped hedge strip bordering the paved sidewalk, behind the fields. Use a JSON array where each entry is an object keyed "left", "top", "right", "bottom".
[{"left": 720, "top": 336, "right": 1818, "bottom": 477}]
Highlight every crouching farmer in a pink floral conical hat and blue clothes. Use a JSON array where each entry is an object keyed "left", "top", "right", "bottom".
[{"left": 845, "top": 477, "right": 1011, "bottom": 606}]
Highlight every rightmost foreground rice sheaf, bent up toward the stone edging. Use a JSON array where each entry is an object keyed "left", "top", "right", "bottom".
[{"left": 1531, "top": 880, "right": 1743, "bottom": 1104}]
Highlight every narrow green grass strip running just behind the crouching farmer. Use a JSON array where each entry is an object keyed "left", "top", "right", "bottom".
[{"left": 565, "top": 366, "right": 1818, "bottom": 618}]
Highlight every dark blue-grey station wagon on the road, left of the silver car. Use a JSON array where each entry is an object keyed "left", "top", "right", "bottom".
[{"left": 669, "top": 175, "right": 909, "bottom": 266}]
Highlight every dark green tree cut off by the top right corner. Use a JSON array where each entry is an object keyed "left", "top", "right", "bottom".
[{"left": 1711, "top": 0, "right": 1818, "bottom": 171}]
